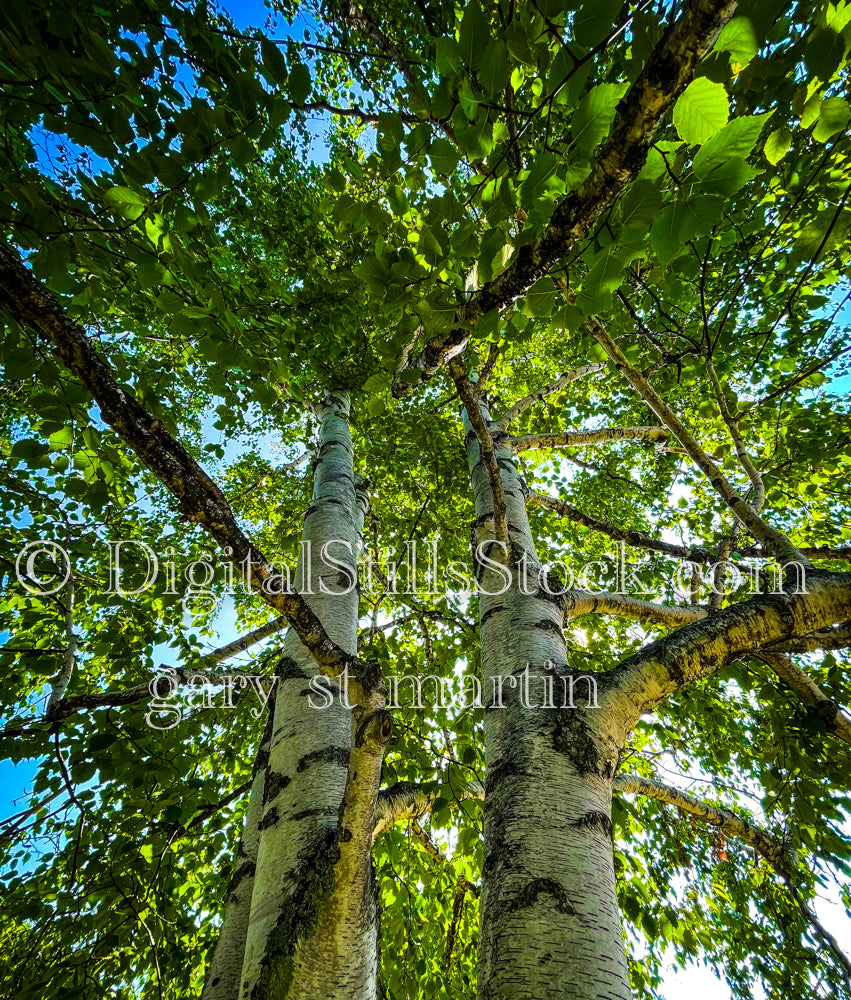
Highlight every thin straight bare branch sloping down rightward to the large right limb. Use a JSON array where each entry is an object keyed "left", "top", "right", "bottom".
[{"left": 588, "top": 318, "right": 809, "bottom": 566}]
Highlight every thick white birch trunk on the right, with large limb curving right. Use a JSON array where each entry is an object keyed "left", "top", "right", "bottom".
[{"left": 465, "top": 407, "right": 631, "bottom": 1000}]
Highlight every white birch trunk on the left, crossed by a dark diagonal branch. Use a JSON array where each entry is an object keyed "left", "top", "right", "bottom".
[{"left": 239, "top": 393, "right": 390, "bottom": 1000}]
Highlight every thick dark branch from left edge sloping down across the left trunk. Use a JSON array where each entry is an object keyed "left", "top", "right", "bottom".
[{"left": 0, "top": 246, "right": 381, "bottom": 703}]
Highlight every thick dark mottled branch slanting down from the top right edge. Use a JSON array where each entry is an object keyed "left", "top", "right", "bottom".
[{"left": 393, "top": 0, "right": 737, "bottom": 396}]
